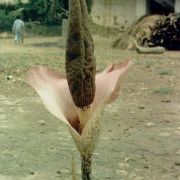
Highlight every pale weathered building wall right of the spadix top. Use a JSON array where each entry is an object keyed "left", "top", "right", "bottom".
[{"left": 91, "top": 0, "right": 146, "bottom": 27}]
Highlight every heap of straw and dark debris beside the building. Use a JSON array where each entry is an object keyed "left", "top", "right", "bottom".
[{"left": 112, "top": 14, "right": 180, "bottom": 50}]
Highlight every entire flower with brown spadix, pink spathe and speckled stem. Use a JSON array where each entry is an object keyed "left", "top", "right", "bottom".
[{"left": 27, "top": 0, "right": 131, "bottom": 180}]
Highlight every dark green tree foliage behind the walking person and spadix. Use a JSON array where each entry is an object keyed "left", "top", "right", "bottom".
[{"left": 0, "top": 0, "right": 93, "bottom": 24}]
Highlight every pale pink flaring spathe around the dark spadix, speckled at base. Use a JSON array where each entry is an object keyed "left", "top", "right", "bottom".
[{"left": 27, "top": 61, "right": 131, "bottom": 154}]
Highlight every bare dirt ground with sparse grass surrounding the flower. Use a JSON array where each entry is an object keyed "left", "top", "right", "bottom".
[{"left": 0, "top": 37, "right": 180, "bottom": 180}]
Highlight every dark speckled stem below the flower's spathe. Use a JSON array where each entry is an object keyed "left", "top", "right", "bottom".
[{"left": 81, "top": 155, "right": 92, "bottom": 180}]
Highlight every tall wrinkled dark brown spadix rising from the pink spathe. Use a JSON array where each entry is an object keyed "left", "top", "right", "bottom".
[{"left": 66, "top": 0, "right": 96, "bottom": 108}]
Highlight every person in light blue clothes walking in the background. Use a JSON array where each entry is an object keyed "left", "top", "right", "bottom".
[{"left": 12, "top": 16, "right": 24, "bottom": 44}]
